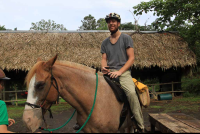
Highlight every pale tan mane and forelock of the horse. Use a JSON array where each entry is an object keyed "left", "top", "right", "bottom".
[{"left": 25, "top": 61, "right": 102, "bottom": 87}]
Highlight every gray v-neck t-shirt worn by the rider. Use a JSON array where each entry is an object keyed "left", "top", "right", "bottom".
[{"left": 101, "top": 33, "right": 133, "bottom": 70}]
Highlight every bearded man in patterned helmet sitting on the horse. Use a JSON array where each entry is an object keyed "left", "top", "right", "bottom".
[{"left": 101, "top": 13, "right": 144, "bottom": 132}]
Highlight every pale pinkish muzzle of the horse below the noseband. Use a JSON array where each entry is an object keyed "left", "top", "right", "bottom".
[{"left": 23, "top": 108, "right": 43, "bottom": 133}]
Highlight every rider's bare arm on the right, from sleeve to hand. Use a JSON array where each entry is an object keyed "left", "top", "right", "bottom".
[{"left": 109, "top": 47, "right": 134, "bottom": 78}]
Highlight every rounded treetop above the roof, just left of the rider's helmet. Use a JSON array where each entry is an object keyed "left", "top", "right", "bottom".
[{"left": 79, "top": 14, "right": 97, "bottom": 30}]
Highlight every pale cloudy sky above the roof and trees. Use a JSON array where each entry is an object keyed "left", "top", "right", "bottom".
[{"left": 0, "top": 0, "right": 156, "bottom": 30}]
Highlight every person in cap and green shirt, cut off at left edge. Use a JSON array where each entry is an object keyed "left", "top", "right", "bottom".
[{"left": 0, "top": 69, "right": 15, "bottom": 133}]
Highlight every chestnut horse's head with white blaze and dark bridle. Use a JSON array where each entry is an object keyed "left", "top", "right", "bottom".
[{"left": 23, "top": 55, "right": 59, "bottom": 132}]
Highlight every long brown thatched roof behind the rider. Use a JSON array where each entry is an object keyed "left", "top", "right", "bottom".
[{"left": 0, "top": 31, "right": 196, "bottom": 70}]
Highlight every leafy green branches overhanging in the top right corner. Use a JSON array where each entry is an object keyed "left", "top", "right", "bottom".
[{"left": 133, "top": 0, "right": 200, "bottom": 27}]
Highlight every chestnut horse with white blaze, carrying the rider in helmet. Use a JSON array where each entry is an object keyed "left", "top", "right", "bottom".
[{"left": 23, "top": 55, "right": 136, "bottom": 133}]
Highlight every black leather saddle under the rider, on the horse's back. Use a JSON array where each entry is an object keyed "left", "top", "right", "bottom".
[{"left": 103, "top": 74, "right": 129, "bottom": 129}]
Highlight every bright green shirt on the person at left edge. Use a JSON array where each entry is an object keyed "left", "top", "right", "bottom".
[{"left": 0, "top": 100, "right": 8, "bottom": 125}]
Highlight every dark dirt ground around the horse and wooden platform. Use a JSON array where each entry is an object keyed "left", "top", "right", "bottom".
[{"left": 9, "top": 98, "right": 200, "bottom": 133}]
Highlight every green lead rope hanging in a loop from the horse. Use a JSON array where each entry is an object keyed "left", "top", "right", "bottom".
[{"left": 39, "top": 73, "right": 98, "bottom": 133}]
